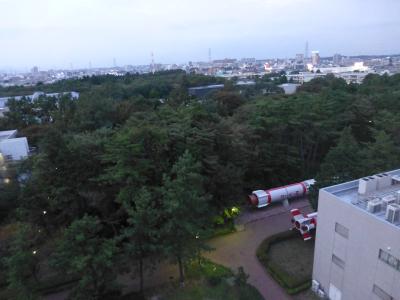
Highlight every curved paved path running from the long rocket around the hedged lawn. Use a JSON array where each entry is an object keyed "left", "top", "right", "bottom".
[{"left": 205, "top": 200, "right": 311, "bottom": 300}]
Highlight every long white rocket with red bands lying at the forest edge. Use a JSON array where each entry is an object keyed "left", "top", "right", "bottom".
[{"left": 249, "top": 179, "right": 315, "bottom": 208}]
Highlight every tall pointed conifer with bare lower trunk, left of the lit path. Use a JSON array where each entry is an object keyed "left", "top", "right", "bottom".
[{"left": 161, "top": 151, "right": 209, "bottom": 283}]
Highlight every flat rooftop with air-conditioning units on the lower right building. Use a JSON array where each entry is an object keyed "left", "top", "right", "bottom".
[{"left": 322, "top": 169, "right": 400, "bottom": 230}]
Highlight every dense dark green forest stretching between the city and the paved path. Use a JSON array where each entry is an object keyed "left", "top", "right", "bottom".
[{"left": 0, "top": 71, "right": 400, "bottom": 299}]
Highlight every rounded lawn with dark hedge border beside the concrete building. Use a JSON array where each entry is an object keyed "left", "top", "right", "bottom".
[{"left": 257, "top": 231, "right": 314, "bottom": 294}]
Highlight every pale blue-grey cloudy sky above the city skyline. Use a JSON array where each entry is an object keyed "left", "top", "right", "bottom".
[{"left": 0, "top": 0, "right": 400, "bottom": 70}]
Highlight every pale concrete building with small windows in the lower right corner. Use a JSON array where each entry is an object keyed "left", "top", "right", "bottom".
[{"left": 313, "top": 170, "right": 400, "bottom": 300}]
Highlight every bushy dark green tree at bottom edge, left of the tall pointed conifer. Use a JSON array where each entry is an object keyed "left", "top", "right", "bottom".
[{"left": 51, "top": 215, "right": 117, "bottom": 299}]
